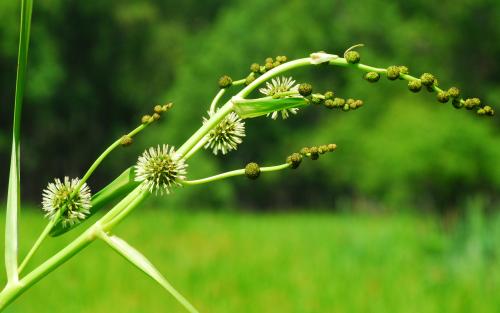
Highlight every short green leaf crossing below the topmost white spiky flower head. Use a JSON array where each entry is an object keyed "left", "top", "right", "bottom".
[{"left": 234, "top": 98, "right": 308, "bottom": 118}]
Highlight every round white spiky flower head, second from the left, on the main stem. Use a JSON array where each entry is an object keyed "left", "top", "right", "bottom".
[{"left": 135, "top": 145, "right": 187, "bottom": 195}]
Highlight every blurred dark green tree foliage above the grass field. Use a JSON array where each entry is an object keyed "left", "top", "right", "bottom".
[{"left": 0, "top": 0, "right": 500, "bottom": 210}]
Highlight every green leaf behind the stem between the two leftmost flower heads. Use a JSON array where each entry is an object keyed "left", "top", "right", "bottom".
[{"left": 50, "top": 167, "right": 139, "bottom": 237}]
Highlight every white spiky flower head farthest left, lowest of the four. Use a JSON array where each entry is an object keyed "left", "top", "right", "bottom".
[{"left": 42, "top": 176, "right": 92, "bottom": 227}]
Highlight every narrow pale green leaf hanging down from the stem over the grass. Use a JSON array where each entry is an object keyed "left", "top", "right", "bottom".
[{"left": 99, "top": 232, "right": 198, "bottom": 313}]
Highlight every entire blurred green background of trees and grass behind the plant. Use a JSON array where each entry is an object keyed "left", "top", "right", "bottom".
[{"left": 0, "top": 0, "right": 500, "bottom": 312}]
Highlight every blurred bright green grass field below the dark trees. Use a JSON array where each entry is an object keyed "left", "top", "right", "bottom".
[{"left": 0, "top": 210, "right": 500, "bottom": 313}]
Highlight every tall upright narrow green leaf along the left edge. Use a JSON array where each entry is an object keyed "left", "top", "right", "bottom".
[{"left": 5, "top": 0, "right": 33, "bottom": 283}]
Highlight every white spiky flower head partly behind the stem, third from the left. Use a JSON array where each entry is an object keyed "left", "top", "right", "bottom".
[{"left": 203, "top": 112, "right": 245, "bottom": 155}]
